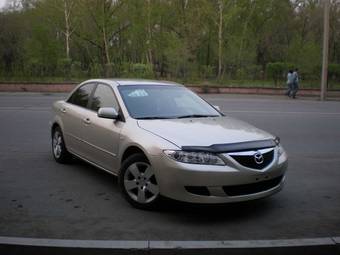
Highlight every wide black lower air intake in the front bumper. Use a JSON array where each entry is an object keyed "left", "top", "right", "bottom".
[{"left": 223, "top": 175, "right": 283, "bottom": 196}]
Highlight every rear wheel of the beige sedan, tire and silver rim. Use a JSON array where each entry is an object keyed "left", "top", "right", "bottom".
[{"left": 52, "top": 126, "right": 72, "bottom": 164}]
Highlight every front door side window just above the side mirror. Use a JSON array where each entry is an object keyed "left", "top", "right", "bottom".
[{"left": 91, "top": 84, "right": 118, "bottom": 111}]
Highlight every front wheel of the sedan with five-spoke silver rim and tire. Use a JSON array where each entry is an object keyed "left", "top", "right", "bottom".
[{"left": 119, "top": 153, "right": 160, "bottom": 210}]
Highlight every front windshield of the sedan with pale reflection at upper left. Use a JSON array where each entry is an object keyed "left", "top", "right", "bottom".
[{"left": 118, "top": 85, "right": 221, "bottom": 119}]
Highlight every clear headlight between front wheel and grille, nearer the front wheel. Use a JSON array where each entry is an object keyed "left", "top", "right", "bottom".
[{"left": 164, "top": 150, "right": 225, "bottom": 166}]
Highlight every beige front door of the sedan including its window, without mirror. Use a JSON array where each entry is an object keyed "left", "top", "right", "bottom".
[{"left": 82, "top": 84, "right": 124, "bottom": 172}]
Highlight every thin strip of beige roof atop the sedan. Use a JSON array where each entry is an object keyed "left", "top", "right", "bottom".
[{"left": 83, "top": 79, "right": 183, "bottom": 86}]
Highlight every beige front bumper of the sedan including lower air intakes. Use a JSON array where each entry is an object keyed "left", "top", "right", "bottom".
[{"left": 150, "top": 149, "right": 288, "bottom": 204}]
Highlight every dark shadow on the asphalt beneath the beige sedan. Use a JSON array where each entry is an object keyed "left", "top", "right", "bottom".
[{"left": 66, "top": 156, "right": 280, "bottom": 224}]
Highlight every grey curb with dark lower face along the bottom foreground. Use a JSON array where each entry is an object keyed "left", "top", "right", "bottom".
[{"left": 0, "top": 237, "right": 340, "bottom": 255}]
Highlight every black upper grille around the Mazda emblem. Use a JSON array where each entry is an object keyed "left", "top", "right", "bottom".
[{"left": 228, "top": 149, "right": 274, "bottom": 170}]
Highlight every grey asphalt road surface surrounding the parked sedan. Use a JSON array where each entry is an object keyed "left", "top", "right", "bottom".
[{"left": 0, "top": 93, "right": 340, "bottom": 240}]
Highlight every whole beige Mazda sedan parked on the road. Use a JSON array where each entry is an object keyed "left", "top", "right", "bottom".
[{"left": 51, "top": 79, "right": 287, "bottom": 209}]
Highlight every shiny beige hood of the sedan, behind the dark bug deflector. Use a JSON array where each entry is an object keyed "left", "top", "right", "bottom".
[{"left": 138, "top": 117, "right": 274, "bottom": 147}]
